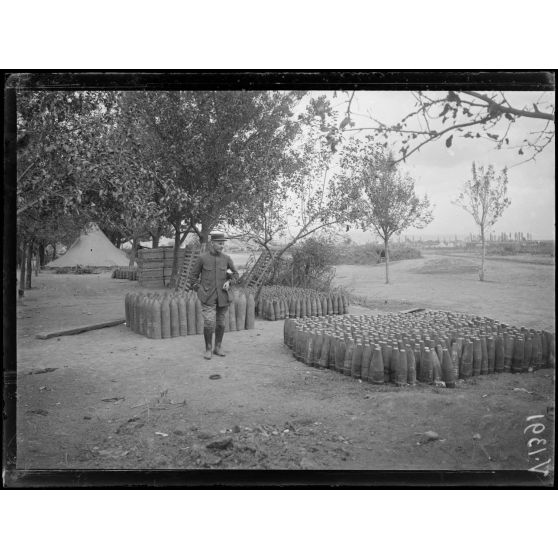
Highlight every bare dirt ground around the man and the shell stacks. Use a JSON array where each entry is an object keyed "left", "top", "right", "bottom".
[{"left": 17, "top": 253, "right": 555, "bottom": 484}]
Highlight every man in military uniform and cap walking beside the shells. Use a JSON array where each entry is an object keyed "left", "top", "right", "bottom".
[{"left": 192, "top": 231, "right": 238, "bottom": 360}]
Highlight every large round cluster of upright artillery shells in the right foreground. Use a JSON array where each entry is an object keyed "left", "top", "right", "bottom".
[{"left": 279, "top": 307, "right": 555, "bottom": 388}]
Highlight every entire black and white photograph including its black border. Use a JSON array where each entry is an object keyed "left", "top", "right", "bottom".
[{"left": 3, "top": 71, "right": 555, "bottom": 487}]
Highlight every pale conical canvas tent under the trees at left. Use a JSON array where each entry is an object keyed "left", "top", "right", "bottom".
[{"left": 47, "top": 224, "right": 130, "bottom": 267}]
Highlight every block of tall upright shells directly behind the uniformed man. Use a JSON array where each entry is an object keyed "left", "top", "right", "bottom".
[{"left": 124, "top": 289, "right": 255, "bottom": 339}]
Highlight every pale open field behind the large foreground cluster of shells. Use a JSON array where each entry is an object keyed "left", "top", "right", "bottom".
[{"left": 334, "top": 251, "right": 555, "bottom": 331}]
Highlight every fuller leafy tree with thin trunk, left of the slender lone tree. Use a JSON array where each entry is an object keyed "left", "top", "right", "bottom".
[{"left": 336, "top": 138, "right": 432, "bottom": 283}]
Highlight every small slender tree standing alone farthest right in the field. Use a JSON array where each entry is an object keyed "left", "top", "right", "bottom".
[{"left": 453, "top": 163, "right": 511, "bottom": 281}]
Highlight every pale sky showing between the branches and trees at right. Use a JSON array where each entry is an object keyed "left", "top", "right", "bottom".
[{"left": 302, "top": 91, "right": 555, "bottom": 242}]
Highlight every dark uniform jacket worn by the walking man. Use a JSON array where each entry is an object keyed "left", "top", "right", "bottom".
[{"left": 192, "top": 251, "right": 238, "bottom": 306}]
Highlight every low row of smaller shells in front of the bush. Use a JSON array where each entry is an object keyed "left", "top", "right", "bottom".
[{"left": 256, "top": 285, "right": 349, "bottom": 320}]
